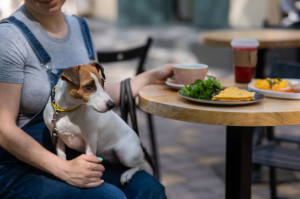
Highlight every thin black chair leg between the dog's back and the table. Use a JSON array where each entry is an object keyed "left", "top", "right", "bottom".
[{"left": 147, "top": 113, "right": 160, "bottom": 179}]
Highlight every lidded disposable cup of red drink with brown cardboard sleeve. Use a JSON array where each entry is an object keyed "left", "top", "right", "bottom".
[{"left": 231, "top": 38, "right": 259, "bottom": 83}]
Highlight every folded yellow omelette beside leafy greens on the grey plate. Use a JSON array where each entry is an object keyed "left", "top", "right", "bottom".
[{"left": 212, "top": 87, "right": 255, "bottom": 101}]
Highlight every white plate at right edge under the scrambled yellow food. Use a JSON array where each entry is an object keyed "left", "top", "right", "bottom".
[{"left": 248, "top": 79, "right": 300, "bottom": 99}]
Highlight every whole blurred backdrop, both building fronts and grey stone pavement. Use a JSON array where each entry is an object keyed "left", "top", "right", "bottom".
[{"left": 0, "top": 0, "right": 300, "bottom": 199}]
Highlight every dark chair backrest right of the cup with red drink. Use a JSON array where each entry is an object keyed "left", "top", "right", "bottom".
[{"left": 270, "top": 55, "right": 300, "bottom": 79}]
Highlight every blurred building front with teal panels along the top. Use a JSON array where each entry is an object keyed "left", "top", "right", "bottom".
[{"left": 0, "top": 0, "right": 281, "bottom": 28}]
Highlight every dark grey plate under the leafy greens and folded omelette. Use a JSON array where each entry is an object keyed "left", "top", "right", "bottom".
[{"left": 178, "top": 89, "right": 264, "bottom": 105}]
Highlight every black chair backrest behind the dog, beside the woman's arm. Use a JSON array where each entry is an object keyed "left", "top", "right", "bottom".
[{"left": 97, "top": 37, "right": 152, "bottom": 75}]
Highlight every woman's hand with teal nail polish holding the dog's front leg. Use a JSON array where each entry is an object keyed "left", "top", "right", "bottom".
[{"left": 57, "top": 155, "right": 105, "bottom": 188}]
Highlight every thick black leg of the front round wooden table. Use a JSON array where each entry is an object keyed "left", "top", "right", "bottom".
[{"left": 225, "top": 126, "right": 254, "bottom": 199}]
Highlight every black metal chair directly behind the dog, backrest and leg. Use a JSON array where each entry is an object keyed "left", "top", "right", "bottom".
[{"left": 97, "top": 37, "right": 160, "bottom": 179}]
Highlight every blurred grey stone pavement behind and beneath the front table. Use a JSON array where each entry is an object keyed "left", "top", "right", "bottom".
[{"left": 88, "top": 19, "right": 300, "bottom": 199}]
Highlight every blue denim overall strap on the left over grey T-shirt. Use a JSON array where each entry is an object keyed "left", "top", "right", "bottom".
[{"left": 0, "top": 16, "right": 51, "bottom": 65}]
